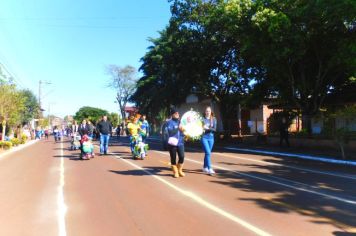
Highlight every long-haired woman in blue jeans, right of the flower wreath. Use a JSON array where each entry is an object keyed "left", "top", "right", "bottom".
[{"left": 201, "top": 107, "right": 217, "bottom": 175}]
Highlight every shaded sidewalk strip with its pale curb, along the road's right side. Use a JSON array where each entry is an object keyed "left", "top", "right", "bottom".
[{"left": 150, "top": 136, "right": 356, "bottom": 166}]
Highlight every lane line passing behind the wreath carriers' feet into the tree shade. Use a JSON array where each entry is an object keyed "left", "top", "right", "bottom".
[{"left": 155, "top": 151, "right": 356, "bottom": 205}]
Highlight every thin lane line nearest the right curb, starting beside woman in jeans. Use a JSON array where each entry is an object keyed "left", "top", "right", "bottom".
[{"left": 147, "top": 139, "right": 356, "bottom": 180}]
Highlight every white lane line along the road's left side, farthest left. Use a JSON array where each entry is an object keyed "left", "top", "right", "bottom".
[{"left": 57, "top": 142, "right": 67, "bottom": 236}]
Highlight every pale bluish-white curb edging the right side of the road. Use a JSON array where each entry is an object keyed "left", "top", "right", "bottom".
[{"left": 225, "top": 147, "right": 356, "bottom": 166}]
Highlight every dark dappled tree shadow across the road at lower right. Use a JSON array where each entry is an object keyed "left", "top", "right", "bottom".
[{"left": 211, "top": 164, "right": 356, "bottom": 231}]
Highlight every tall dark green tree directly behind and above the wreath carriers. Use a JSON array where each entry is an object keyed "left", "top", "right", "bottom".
[{"left": 132, "top": 0, "right": 255, "bottom": 133}]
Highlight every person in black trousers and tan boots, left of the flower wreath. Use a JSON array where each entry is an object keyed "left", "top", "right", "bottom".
[{"left": 165, "top": 108, "right": 185, "bottom": 178}]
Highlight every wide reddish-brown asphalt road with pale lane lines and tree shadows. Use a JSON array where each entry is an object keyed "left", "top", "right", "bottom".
[{"left": 0, "top": 138, "right": 356, "bottom": 236}]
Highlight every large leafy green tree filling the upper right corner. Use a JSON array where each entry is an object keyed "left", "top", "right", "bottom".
[{"left": 239, "top": 0, "right": 356, "bottom": 132}]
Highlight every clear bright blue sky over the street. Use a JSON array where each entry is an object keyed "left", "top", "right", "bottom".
[{"left": 0, "top": 0, "right": 170, "bottom": 117}]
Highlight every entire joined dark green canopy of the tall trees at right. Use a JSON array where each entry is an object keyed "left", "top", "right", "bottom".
[{"left": 131, "top": 0, "right": 356, "bottom": 133}]
